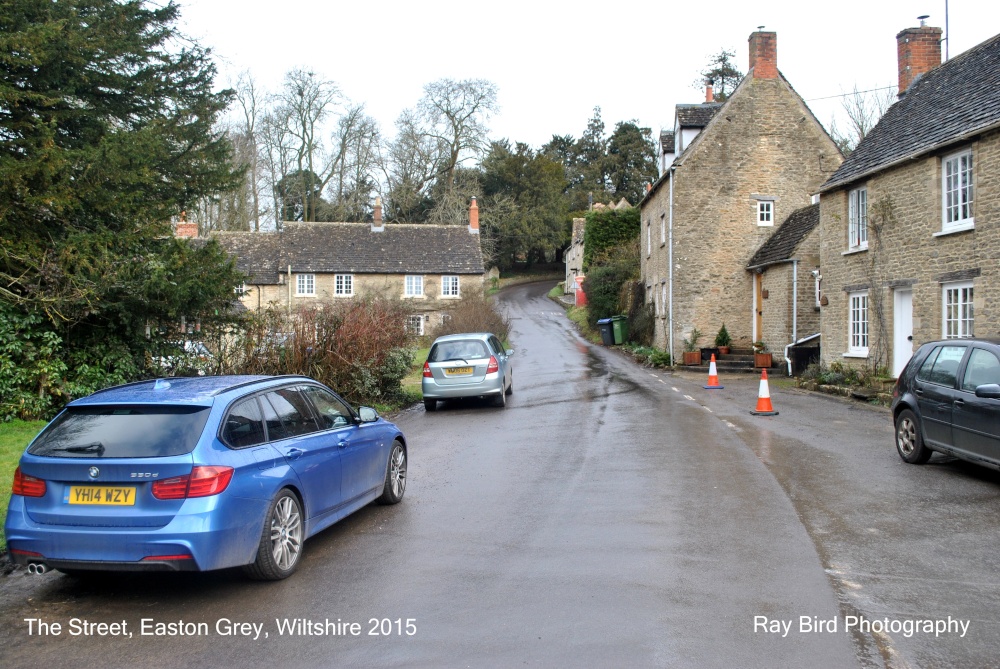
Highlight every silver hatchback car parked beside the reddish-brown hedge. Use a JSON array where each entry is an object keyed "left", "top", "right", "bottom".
[{"left": 420, "top": 332, "right": 514, "bottom": 411}]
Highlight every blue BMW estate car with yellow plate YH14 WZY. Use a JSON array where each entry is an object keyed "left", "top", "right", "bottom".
[{"left": 5, "top": 376, "right": 407, "bottom": 580}]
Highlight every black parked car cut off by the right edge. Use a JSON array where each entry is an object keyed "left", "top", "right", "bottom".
[{"left": 892, "top": 339, "right": 1000, "bottom": 469}]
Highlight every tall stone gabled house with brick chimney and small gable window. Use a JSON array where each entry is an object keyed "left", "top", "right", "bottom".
[{"left": 640, "top": 32, "right": 843, "bottom": 360}]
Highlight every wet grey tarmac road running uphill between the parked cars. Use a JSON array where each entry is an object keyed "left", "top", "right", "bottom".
[{"left": 0, "top": 285, "right": 1000, "bottom": 667}]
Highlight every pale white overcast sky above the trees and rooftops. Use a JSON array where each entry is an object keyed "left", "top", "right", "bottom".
[{"left": 179, "top": 0, "right": 1000, "bottom": 148}]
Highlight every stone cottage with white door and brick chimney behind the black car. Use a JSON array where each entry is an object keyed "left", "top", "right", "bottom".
[{"left": 820, "top": 25, "right": 1000, "bottom": 375}]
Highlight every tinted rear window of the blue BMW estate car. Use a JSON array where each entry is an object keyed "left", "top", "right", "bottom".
[{"left": 28, "top": 406, "right": 209, "bottom": 458}]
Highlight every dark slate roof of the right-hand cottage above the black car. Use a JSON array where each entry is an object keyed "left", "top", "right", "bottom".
[{"left": 820, "top": 35, "right": 1000, "bottom": 192}]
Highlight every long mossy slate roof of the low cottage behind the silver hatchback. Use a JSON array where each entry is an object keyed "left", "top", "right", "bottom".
[{"left": 216, "top": 222, "right": 484, "bottom": 285}]
